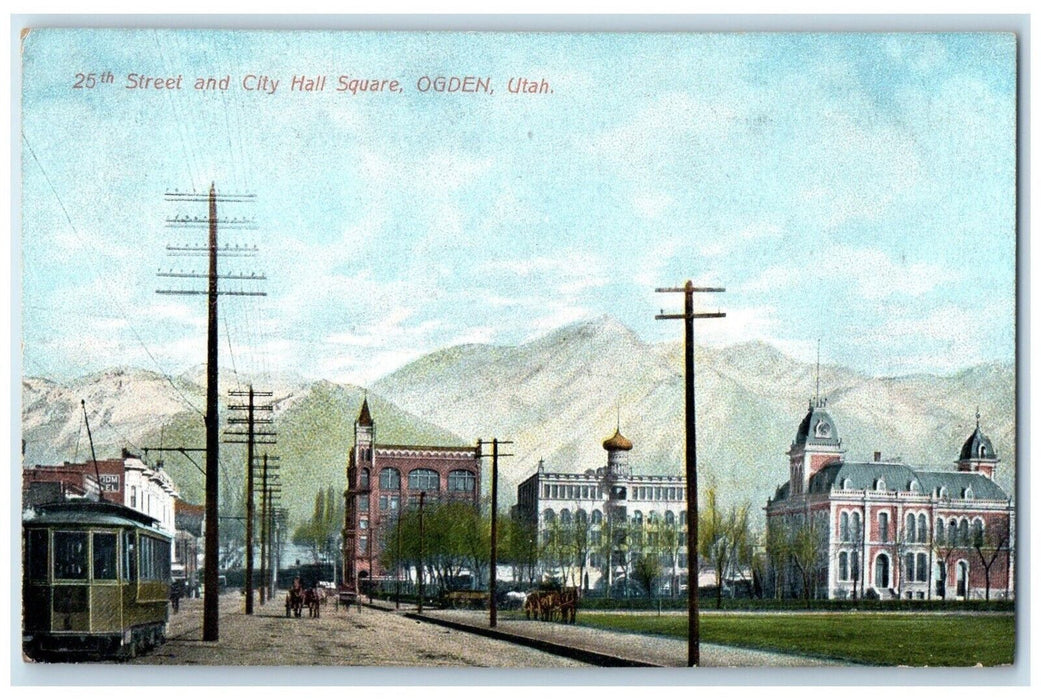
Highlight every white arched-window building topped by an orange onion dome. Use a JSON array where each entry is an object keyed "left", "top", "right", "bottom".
[{"left": 516, "top": 422, "right": 687, "bottom": 593}]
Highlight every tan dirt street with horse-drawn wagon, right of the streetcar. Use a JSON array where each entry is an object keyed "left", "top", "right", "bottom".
[{"left": 128, "top": 594, "right": 584, "bottom": 668}]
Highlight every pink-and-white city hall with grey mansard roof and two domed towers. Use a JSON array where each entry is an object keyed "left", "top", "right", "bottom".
[{"left": 766, "top": 399, "right": 1015, "bottom": 600}]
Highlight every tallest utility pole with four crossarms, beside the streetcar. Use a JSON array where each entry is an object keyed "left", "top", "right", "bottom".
[{"left": 156, "top": 183, "right": 264, "bottom": 642}]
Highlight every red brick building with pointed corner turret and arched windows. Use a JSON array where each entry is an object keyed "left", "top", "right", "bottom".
[{"left": 344, "top": 399, "right": 481, "bottom": 589}]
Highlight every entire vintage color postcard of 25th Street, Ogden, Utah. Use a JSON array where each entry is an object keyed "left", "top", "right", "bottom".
[{"left": 16, "top": 28, "right": 1021, "bottom": 678}]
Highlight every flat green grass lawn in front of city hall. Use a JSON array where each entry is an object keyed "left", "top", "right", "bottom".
[{"left": 578, "top": 610, "right": 1015, "bottom": 667}]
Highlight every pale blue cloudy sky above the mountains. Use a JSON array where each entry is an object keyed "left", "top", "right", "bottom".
[{"left": 21, "top": 29, "right": 1016, "bottom": 384}]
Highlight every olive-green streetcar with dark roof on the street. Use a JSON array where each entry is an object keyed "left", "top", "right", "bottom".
[{"left": 22, "top": 501, "right": 171, "bottom": 660}]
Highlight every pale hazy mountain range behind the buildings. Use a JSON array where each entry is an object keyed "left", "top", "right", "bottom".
[{"left": 22, "top": 317, "right": 1016, "bottom": 522}]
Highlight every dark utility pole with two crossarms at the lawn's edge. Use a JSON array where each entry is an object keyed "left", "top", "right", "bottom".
[{"left": 654, "top": 279, "right": 727, "bottom": 667}]
